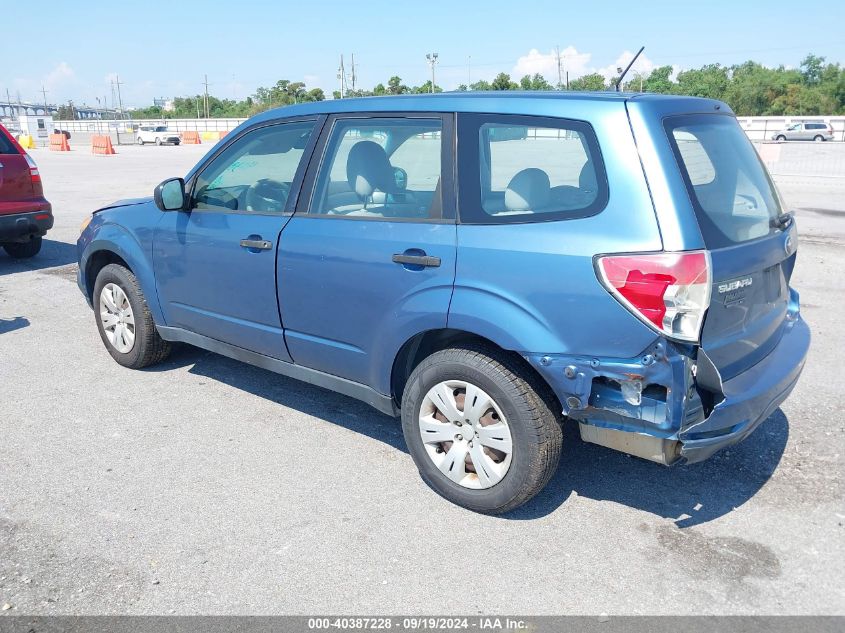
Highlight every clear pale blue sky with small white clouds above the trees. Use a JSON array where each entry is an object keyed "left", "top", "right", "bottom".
[{"left": 0, "top": 0, "right": 845, "bottom": 106}]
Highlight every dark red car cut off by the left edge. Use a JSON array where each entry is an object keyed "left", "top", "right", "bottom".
[{"left": 0, "top": 125, "right": 53, "bottom": 259}]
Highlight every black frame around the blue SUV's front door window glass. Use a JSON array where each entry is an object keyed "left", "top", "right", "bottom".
[{"left": 185, "top": 114, "right": 327, "bottom": 218}]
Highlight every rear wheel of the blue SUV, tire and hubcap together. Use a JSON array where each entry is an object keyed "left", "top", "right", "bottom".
[{"left": 402, "top": 345, "right": 562, "bottom": 514}]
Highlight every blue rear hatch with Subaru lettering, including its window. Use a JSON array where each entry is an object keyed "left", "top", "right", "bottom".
[{"left": 664, "top": 114, "right": 797, "bottom": 380}]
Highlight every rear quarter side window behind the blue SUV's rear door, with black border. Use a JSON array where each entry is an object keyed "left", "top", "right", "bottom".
[{"left": 458, "top": 114, "right": 608, "bottom": 224}]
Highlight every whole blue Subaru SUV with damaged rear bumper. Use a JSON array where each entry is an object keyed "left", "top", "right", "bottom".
[{"left": 78, "top": 93, "right": 810, "bottom": 513}]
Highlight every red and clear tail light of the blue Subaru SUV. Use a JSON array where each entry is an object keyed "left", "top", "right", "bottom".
[{"left": 598, "top": 251, "right": 711, "bottom": 341}]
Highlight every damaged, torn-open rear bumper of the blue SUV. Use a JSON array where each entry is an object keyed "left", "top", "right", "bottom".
[{"left": 525, "top": 311, "right": 810, "bottom": 464}]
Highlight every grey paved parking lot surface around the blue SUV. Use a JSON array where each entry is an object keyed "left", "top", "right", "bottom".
[{"left": 0, "top": 144, "right": 845, "bottom": 615}]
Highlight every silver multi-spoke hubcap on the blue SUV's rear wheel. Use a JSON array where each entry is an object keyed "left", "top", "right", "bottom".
[{"left": 419, "top": 380, "right": 513, "bottom": 489}]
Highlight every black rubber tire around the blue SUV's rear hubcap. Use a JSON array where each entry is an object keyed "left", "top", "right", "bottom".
[{"left": 402, "top": 344, "right": 562, "bottom": 514}]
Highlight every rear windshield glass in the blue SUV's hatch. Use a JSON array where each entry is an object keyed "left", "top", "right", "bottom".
[{"left": 664, "top": 114, "right": 782, "bottom": 248}]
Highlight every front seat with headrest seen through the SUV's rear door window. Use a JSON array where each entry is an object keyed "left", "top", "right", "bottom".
[{"left": 333, "top": 141, "right": 396, "bottom": 216}]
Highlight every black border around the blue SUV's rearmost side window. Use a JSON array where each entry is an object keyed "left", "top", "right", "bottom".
[{"left": 455, "top": 112, "right": 610, "bottom": 225}]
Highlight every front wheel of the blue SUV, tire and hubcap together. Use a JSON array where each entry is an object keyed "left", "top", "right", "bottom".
[{"left": 94, "top": 264, "right": 170, "bottom": 369}]
